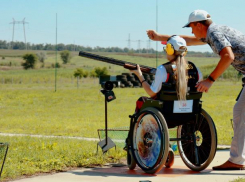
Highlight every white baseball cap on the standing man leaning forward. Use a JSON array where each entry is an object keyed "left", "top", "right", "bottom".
[{"left": 183, "top": 9, "right": 211, "bottom": 28}]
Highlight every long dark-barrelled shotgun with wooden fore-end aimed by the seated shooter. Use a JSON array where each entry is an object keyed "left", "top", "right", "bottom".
[{"left": 79, "top": 51, "right": 156, "bottom": 75}]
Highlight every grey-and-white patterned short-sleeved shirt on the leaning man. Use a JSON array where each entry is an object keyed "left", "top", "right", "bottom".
[{"left": 202, "top": 23, "right": 245, "bottom": 74}]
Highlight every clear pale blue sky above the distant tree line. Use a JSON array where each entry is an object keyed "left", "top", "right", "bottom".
[{"left": 0, "top": 0, "right": 245, "bottom": 52}]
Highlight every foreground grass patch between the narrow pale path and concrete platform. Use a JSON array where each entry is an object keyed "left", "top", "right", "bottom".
[{"left": 1, "top": 136, "right": 126, "bottom": 181}]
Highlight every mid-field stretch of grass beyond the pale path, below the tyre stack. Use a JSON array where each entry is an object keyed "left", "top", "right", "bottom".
[{"left": 0, "top": 80, "right": 241, "bottom": 144}]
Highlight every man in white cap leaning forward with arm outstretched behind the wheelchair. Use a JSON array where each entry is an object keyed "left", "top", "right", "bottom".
[{"left": 147, "top": 10, "right": 245, "bottom": 170}]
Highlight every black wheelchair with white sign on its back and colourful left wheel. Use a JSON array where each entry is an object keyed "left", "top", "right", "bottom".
[{"left": 126, "top": 85, "right": 217, "bottom": 174}]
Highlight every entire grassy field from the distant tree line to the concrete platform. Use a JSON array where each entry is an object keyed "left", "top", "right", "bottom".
[{"left": 0, "top": 50, "right": 241, "bottom": 179}]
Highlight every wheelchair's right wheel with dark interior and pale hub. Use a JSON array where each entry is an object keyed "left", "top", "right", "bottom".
[{"left": 177, "top": 109, "right": 217, "bottom": 171}]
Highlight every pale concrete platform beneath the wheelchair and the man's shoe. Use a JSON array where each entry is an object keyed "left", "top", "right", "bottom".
[{"left": 11, "top": 150, "right": 245, "bottom": 182}]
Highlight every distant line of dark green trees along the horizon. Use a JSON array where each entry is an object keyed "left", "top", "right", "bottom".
[{"left": 0, "top": 40, "right": 216, "bottom": 57}]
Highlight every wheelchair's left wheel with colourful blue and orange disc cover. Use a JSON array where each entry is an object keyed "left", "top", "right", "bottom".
[{"left": 131, "top": 107, "right": 169, "bottom": 174}]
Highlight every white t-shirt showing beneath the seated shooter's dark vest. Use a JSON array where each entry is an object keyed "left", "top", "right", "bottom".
[{"left": 150, "top": 65, "right": 203, "bottom": 93}]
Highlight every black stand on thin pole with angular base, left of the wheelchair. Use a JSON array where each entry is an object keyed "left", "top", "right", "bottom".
[{"left": 97, "top": 81, "right": 116, "bottom": 153}]
